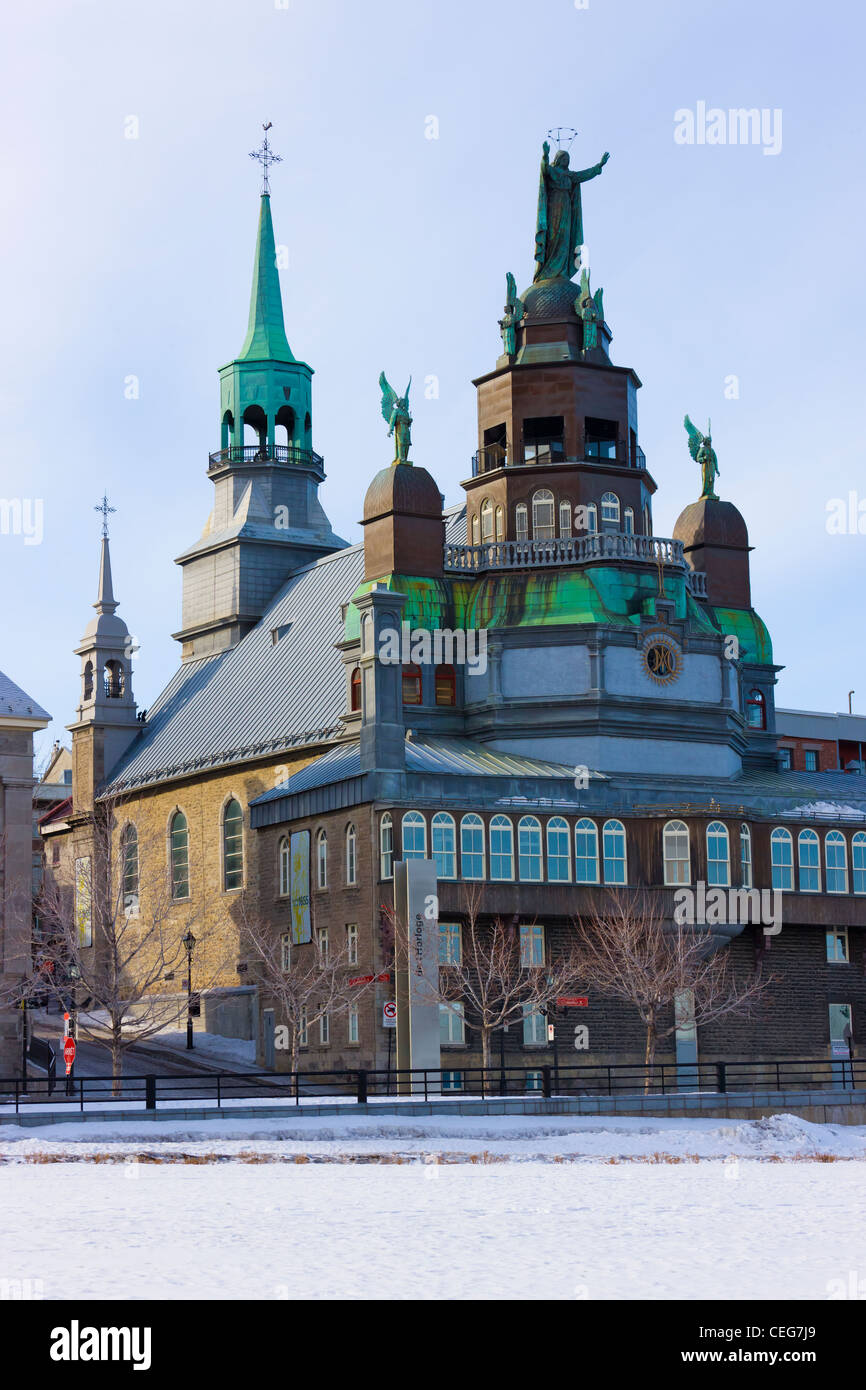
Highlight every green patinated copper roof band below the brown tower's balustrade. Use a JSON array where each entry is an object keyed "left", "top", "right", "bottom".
[{"left": 345, "top": 566, "right": 773, "bottom": 664}]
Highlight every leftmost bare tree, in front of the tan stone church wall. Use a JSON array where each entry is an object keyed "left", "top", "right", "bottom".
[{"left": 36, "top": 799, "right": 231, "bottom": 1094}]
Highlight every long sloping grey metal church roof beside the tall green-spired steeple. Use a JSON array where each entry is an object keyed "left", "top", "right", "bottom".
[{"left": 106, "top": 507, "right": 466, "bottom": 791}]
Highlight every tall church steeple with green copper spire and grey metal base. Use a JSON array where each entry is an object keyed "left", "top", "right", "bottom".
[{"left": 174, "top": 124, "right": 346, "bottom": 660}]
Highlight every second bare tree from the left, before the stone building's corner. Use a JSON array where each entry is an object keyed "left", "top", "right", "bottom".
[{"left": 239, "top": 902, "right": 375, "bottom": 1072}]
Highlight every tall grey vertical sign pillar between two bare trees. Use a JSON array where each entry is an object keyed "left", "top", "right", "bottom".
[{"left": 393, "top": 859, "right": 441, "bottom": 1094}]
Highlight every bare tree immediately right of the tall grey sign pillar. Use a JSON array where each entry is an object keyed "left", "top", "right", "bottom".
[{"left": 385, "top": 884, "right": 582, "bottom": 1069}]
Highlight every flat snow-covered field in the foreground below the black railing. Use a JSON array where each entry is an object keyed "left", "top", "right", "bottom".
[{"left": 0, "top": 1115, "right": 866, "bottom": 1301}]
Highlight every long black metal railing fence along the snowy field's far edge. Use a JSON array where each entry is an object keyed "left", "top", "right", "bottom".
[{"left": 0, "top": 1058, "right": 866, "bottom": 1113}]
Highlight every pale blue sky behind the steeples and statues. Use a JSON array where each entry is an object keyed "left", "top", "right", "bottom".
[{"left": 0, "top": 0, "right": 866, "bottom": 761}]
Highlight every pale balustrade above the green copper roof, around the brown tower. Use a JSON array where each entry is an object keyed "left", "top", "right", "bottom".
[{"left": 445, "top": 531, "right": 706, "bottom": 598}]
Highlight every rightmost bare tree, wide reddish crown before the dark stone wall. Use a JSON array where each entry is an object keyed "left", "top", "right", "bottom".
[{"left": 575, "top": 891, "right": 773, "bottom": 1090}]
